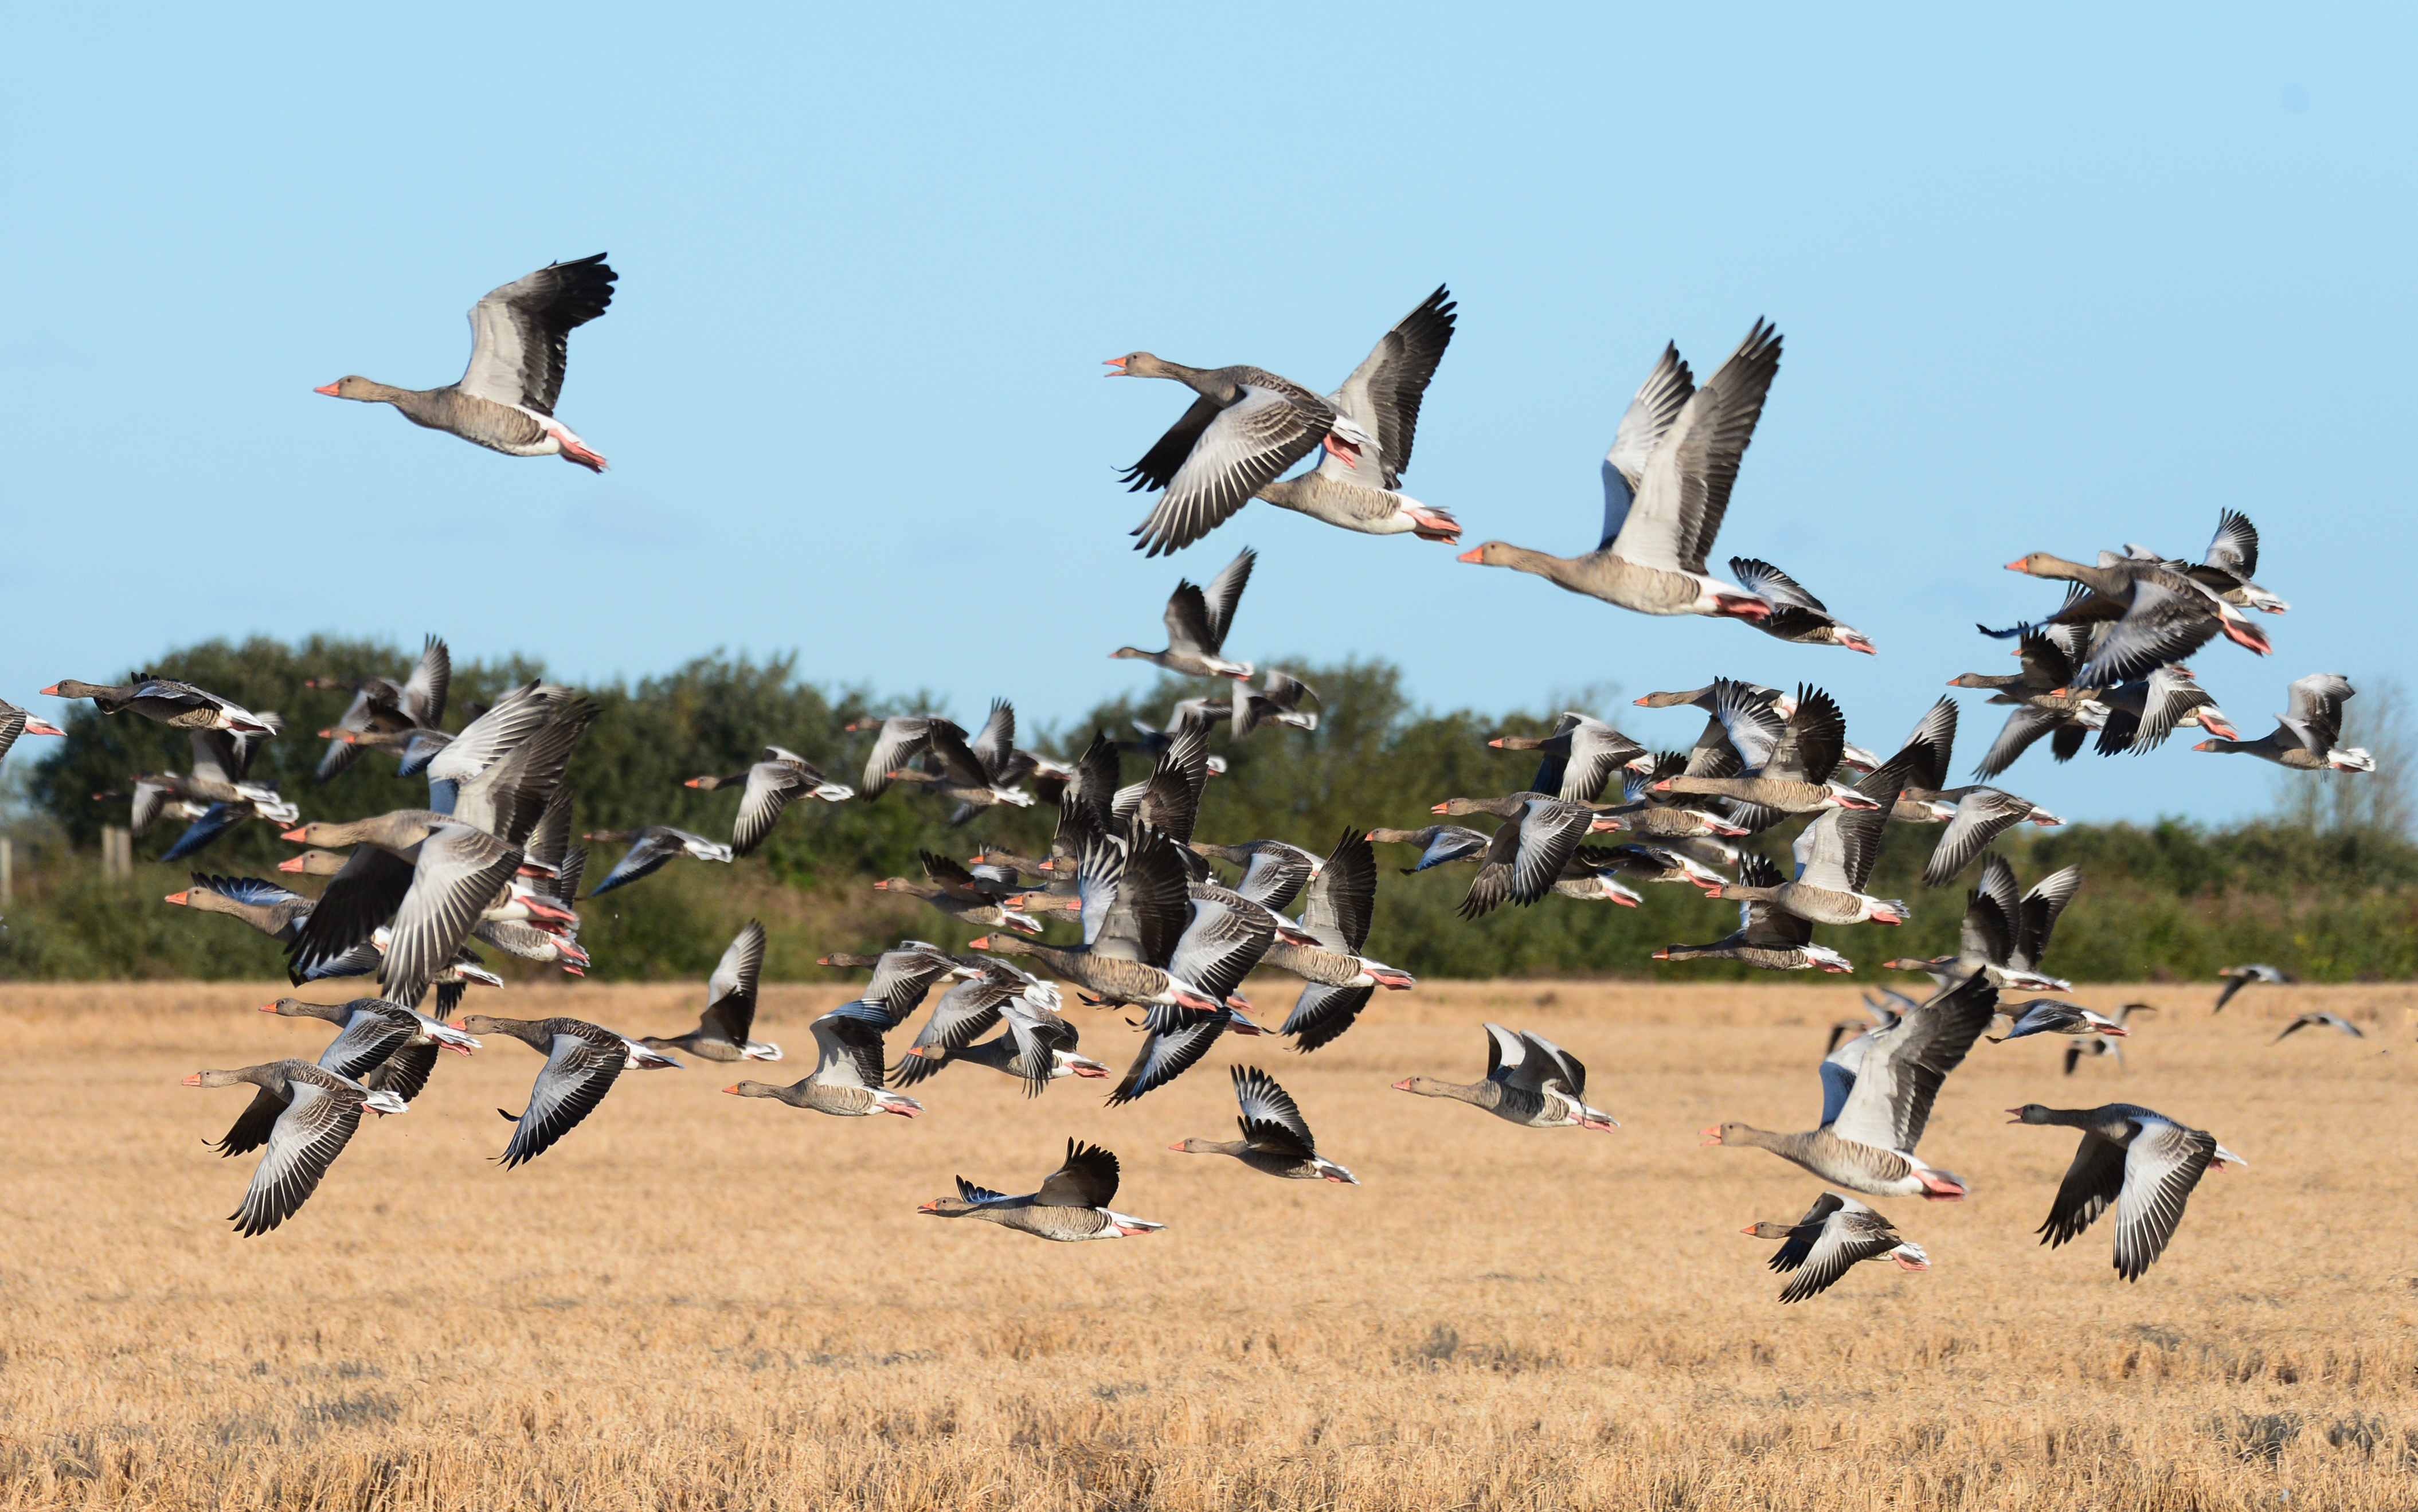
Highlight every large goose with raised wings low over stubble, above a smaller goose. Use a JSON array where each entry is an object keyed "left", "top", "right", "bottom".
[{"left": 1705, "top": 977, "right": 1997, "bottom": 1202}]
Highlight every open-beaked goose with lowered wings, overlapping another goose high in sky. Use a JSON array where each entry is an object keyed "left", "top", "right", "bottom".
[{"left": 1105, "top": 351, "right": 1376, "bottom": 557}]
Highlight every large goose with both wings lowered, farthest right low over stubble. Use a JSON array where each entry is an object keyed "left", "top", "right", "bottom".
[{"left": 2007, "top": 1103, "right": 2249, "bottom": 1282}]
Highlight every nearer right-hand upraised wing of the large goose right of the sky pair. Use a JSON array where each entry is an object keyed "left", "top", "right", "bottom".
[{"left": 1613, "top": 322, "right": 1779, "bottom": 573}]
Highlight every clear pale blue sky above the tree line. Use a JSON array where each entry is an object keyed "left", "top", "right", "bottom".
[{"left": 0, "top": 5, "right": 2418, "bottom": 818}]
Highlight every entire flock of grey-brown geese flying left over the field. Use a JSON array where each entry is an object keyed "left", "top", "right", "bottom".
[{"left": 0, "top": 254, "right": 2374, "bottom": 1302}]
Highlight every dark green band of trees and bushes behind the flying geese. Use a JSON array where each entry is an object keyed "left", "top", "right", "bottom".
[{"left": 0, "top": 639, "right": 2418, "bottom": 980}]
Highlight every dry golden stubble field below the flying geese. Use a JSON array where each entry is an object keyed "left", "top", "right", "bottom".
[{"left": 0, "top": 982, "right": 2418, "bottom": 1512}]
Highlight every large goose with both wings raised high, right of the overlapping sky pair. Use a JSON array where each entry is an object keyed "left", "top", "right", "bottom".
[{"left": 1461, "top": 322, "right": 1779, "bottom": 624}]
